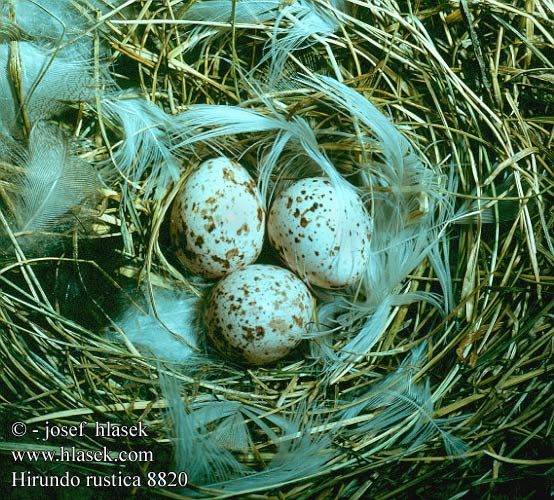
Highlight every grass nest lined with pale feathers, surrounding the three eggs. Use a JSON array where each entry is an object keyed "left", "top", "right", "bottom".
[{"left": 0, "top": 0, "right": 554, "bottom": 499}]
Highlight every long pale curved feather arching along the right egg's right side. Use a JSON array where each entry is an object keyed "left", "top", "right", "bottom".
[{"left": 284, "top": 75, "right": 452, "bottom": 371}]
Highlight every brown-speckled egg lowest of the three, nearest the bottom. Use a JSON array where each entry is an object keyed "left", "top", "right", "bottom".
[{"left": 205, "top": 264, "right": 314, "bottom": 365}]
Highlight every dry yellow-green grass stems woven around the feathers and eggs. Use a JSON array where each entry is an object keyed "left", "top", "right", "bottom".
[{"left": 0, "top": 2, "right": 552, "bottom": 498}]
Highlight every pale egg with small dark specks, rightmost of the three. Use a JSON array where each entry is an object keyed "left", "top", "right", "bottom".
[{"left": 267, "top": 177, "right": 370, "bottom": 288}]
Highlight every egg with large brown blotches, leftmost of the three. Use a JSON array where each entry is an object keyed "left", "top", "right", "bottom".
[{"left": 170, "top": 158, "right": 265, "bottom": 278}]
